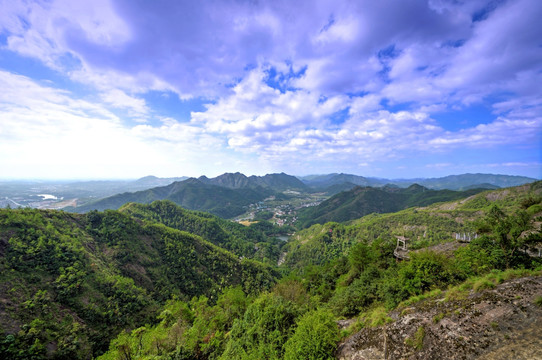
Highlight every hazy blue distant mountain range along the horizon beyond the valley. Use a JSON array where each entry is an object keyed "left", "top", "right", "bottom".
[{"left": 68, "top": 172, "right": 536, "bottom": 219}]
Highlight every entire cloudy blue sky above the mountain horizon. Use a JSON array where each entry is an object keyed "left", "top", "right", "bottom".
[{"left": 0, "top": 0, "right": 542, "bottom": 179}]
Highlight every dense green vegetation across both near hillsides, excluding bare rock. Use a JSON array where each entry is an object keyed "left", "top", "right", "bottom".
[{"left": 0, "top": 182, "right": 542, "bottom": 359}]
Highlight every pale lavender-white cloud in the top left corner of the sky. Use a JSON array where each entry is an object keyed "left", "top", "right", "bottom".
[{"left": 2, "top": 0, "right": 130, "bottom": 70}]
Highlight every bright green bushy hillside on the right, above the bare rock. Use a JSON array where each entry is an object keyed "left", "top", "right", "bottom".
[{"left": 98, "top": 182, "right": 542, "bottom": 359}]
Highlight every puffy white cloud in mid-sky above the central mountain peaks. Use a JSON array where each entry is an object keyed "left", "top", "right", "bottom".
[{"left": 192, "top": 69, "right": 349, "bottom": 151}]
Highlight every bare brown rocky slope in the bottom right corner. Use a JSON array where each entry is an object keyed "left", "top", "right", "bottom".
[{"left": 336, "top": 276, "right": 542, "bottom": 360}]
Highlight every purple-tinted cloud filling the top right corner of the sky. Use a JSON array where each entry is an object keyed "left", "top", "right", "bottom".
[{"left": 436, "top": 0, "right": 542, "bottom": 104}]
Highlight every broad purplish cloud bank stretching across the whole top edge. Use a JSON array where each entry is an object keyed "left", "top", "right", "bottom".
[{"left": 2, "top": 0, "right": 542, "bottom": 103}]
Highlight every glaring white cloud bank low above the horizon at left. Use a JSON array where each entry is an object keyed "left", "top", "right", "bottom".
[{"left": 0, "top": 71, "right": 243, "bottom": 178}]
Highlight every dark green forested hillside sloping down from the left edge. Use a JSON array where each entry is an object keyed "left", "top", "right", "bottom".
[{"left": 0, "top": 209, "right": 277, "bottom": 359}]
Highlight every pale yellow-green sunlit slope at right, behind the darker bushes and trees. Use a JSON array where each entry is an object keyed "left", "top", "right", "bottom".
[{"left": 284, "top": 182, "right": 542, "bottom": 267}]
